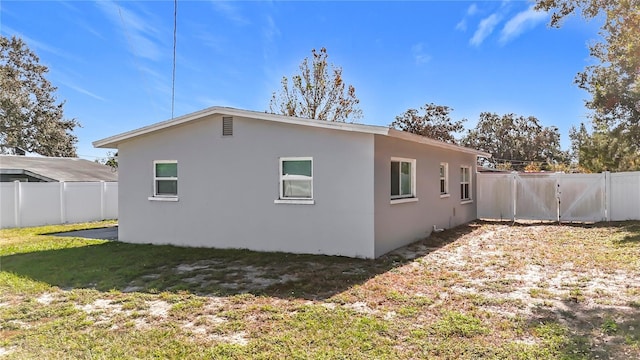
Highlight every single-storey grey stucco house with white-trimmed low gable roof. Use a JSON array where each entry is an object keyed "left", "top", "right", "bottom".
[{"left": 93, "top": 107, "right": 489, "bottom": 258}]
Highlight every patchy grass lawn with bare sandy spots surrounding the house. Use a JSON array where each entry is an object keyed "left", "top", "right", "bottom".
[{"left": 0, "top": 222, "right": 640, "bottom": 359}]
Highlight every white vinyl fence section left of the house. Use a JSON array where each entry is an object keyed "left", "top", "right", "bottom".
[{"left": 0, "top": 181, "right": 118, "bottom": 228}]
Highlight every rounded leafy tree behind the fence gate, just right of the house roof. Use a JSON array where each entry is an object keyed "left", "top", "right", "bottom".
[{"left": 461, "top": 112, "right": 567, "bottom": 170}]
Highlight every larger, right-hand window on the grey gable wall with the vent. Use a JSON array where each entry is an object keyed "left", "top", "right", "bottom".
[{"left": 280, "top": 157, "right": 313, "bottom": 200}]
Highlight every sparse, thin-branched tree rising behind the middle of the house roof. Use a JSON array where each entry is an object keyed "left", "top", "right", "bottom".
[{"left": 269, "top": 48, "right": 362, "bottom": 122}]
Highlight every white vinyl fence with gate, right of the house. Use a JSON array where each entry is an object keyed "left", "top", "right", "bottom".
[{"left": 477, "top": 172, "right": 640, "bottom": 222}]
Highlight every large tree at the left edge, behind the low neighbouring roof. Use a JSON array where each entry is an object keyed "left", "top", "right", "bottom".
[{"left": 0, "top": 36, "right": 79, "bottom": 156}]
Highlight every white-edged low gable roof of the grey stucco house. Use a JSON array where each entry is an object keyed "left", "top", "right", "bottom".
[{"left": 93, "top": 106, "right": 491, "bottom": 157}]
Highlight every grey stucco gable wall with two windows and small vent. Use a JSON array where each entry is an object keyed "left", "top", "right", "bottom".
[{"left": 118, "top": 115, "right": 375, "bottom": 258}]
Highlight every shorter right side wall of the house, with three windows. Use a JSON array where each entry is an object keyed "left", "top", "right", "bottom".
[{"left": 374, "top": 135, "right": 477, "bottom": 257}]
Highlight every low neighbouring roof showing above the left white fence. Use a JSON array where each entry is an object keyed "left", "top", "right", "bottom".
[{"left": 0, "top": 155, "right": 118, "bottom": 181}]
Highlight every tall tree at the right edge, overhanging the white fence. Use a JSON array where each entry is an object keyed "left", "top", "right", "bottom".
[{"left": 536, "top": 0, "right": 640, "bottom": 171}]
